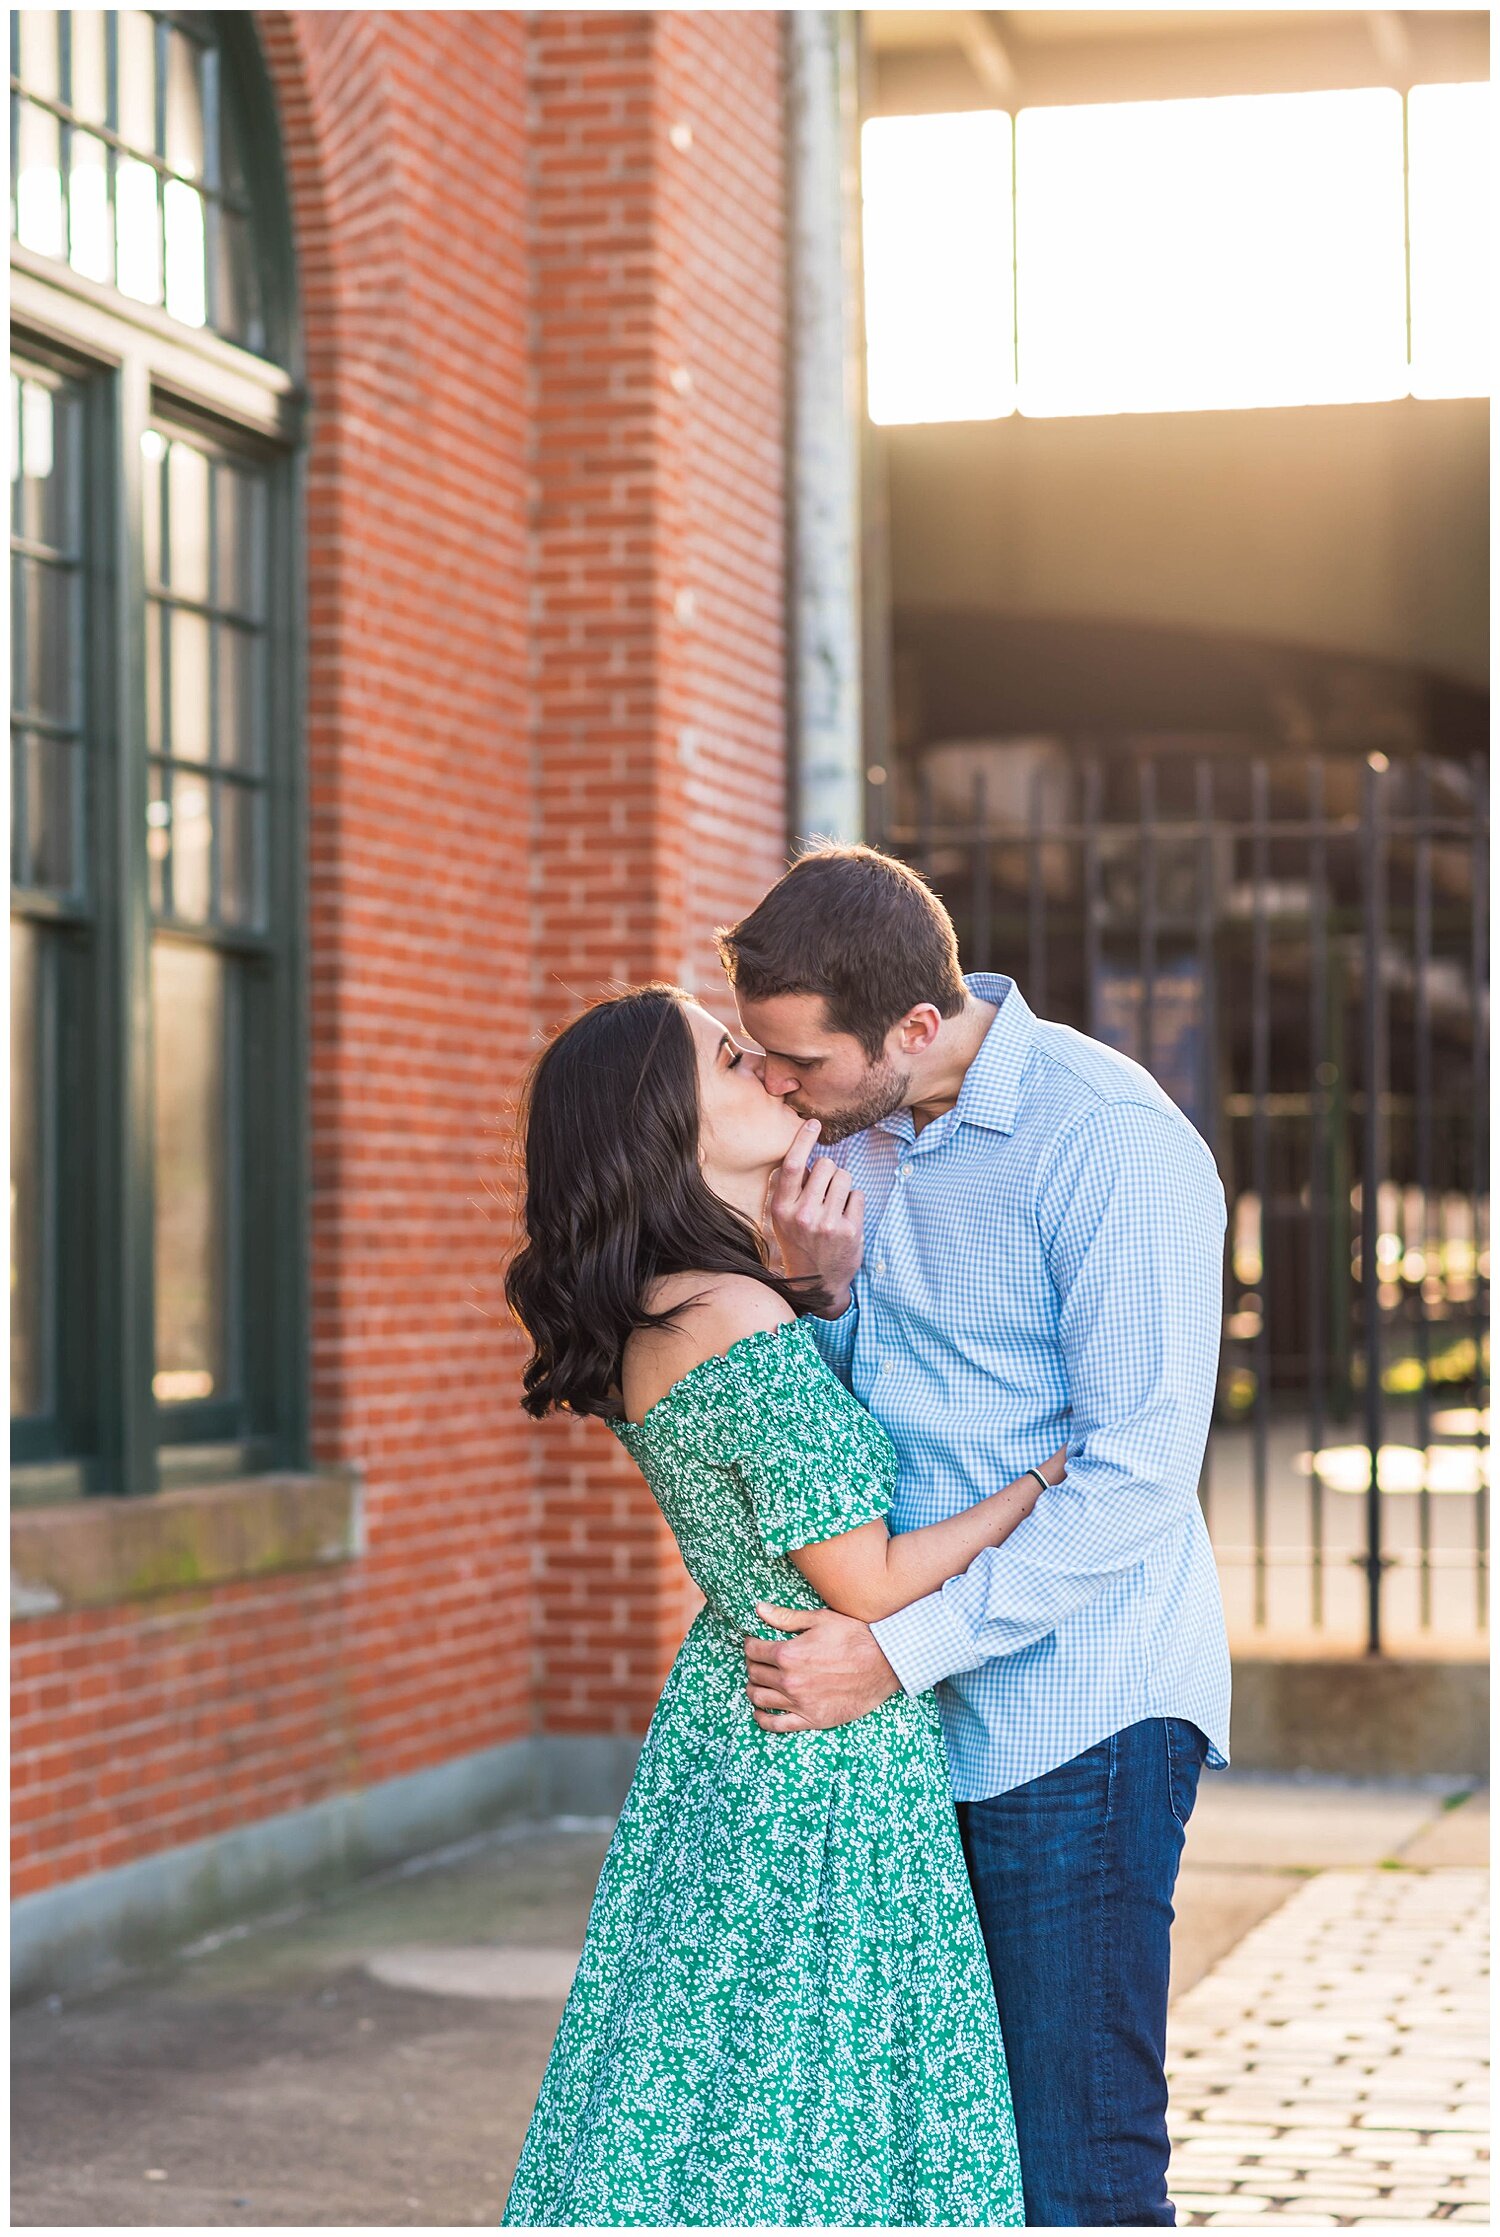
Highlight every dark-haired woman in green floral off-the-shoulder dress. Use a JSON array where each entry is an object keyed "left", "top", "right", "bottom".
[{"left": 505, "top": 987, "right": 1062, "bottom": 2228}]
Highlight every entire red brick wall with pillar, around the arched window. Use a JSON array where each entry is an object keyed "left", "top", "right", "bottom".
[{"left": 13, "top": 11, "right": 785, "bottom": 1895}]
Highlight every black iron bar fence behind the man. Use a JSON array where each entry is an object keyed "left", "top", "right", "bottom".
[{"left": 870, "top": 740, "right": 1489, "bottom": 1653}]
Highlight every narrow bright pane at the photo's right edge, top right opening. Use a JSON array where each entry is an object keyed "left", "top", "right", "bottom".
[{"left": 1406, "top": 83, "right": 1491, "bottom": 396}]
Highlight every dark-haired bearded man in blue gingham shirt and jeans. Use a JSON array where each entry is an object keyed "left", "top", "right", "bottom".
[{"left": 720, "top": 846, "right": 1230, "bottom": 2228}]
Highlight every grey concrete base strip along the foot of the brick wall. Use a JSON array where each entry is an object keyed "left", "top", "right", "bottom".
[{"left": 11, "top": 1738, "right": 639, "bottom": 2002}]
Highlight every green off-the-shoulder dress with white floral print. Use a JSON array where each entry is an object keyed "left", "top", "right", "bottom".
[{"left": 505, "top": 1322, "right": 1024, "bottom": 2228}]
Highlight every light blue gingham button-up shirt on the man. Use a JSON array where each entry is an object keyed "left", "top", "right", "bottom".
[{"left": 807, "top": 973, "right": 1230, "bottom": 1801}]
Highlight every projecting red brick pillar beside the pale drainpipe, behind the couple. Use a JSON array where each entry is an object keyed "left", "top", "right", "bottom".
[{"left": 528, "top": 13, "right": 785, "bottom": 1734}]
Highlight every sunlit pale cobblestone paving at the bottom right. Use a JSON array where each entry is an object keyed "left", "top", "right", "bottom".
[{"left": 1167, "top": 1870, "right": 1491, "bottom": 2228}]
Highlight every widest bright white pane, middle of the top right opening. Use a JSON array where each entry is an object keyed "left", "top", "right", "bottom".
[{"left": 1015, "top": 87, "right": 1406, "bottom": 414}]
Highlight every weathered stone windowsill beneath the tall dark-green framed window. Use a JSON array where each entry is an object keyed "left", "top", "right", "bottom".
[{"left": 11, "top": 1470, "right": 362, "bottom": 1617}]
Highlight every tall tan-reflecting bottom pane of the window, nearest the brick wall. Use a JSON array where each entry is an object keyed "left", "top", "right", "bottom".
[{"left": 152, "top": 940, "right": 228, "bottom": 1403}]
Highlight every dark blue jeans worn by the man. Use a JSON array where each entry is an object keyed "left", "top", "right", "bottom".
[{"left": 959, "top": 1716, "right": 1207, "bottom": 2228}]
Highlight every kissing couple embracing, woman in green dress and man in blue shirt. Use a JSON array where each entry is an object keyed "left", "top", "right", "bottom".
[{"left": 505, "top": 846, "right": 1230, "bottom": 2228}]
